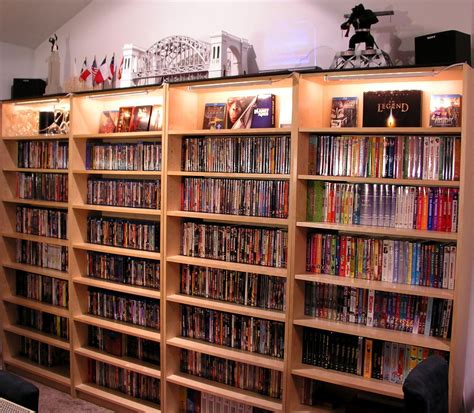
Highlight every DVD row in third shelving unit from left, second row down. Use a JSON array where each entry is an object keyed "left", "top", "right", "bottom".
[{"left": 181, "top": 178, "right": 290, "bottom": 218}]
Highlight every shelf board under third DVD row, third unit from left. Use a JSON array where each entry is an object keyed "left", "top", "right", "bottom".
[{"left": 166, "top": 255, "right": 288, "bottom": 277}]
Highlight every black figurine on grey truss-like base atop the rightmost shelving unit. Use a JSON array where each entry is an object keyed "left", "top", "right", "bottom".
[{"left": 341, "top": 4, "right": 379, "bottom": 50}]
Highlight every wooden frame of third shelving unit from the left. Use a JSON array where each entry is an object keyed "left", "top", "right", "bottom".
[{"left": 164, "top": 76, "right": 294, "bottom": 411}]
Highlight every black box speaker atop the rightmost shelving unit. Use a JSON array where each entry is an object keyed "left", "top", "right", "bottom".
[{"left": 415, "top": 30, "right": 471, "bottom": 65}]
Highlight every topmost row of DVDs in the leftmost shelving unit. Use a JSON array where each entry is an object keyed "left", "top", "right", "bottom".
[{"left": 18, "top": 140, "right": 69, "bottom": 169}]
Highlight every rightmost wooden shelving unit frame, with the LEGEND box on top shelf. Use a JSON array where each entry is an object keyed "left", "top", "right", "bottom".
[{"left": 288, "top": 65, "right": 473, "bottom": 412}]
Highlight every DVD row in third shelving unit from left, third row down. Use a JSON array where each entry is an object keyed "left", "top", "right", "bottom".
[{"left": 181, "top": 221, "right": 288, "bottom": 268}]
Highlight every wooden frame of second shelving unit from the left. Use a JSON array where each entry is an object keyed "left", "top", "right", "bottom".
[{"left": 69, "top": 87, "right": 165, "bottom": 412}]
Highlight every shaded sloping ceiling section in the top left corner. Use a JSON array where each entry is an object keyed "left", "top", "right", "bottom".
[{"left": 0, "top": 0, "right": 92, "bottom": 49}]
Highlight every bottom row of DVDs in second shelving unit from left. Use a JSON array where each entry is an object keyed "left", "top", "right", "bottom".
[{"left": 87, "top": 359, "right": 161, "bottom": 404}]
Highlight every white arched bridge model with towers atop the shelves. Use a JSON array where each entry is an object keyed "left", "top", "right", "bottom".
[{"left": 120, "top": 31, "right": 252, "bottom": 87}]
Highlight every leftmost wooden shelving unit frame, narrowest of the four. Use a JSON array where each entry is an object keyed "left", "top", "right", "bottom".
[{"left": 0, "top": 96, "right": 71, "bottom": 391}]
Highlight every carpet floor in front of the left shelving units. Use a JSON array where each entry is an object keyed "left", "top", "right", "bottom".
[{"left": 19, "top": 378, "right": 113, "bottom": 413}]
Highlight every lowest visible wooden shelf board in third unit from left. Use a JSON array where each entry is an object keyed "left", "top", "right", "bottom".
[{"left": 166, "top": 373, "right": 283, "bottom": 412}]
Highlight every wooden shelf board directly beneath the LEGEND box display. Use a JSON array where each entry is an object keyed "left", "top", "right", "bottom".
[{"left": 299, "top": 127, "right": 461, "bottom": 136}]
